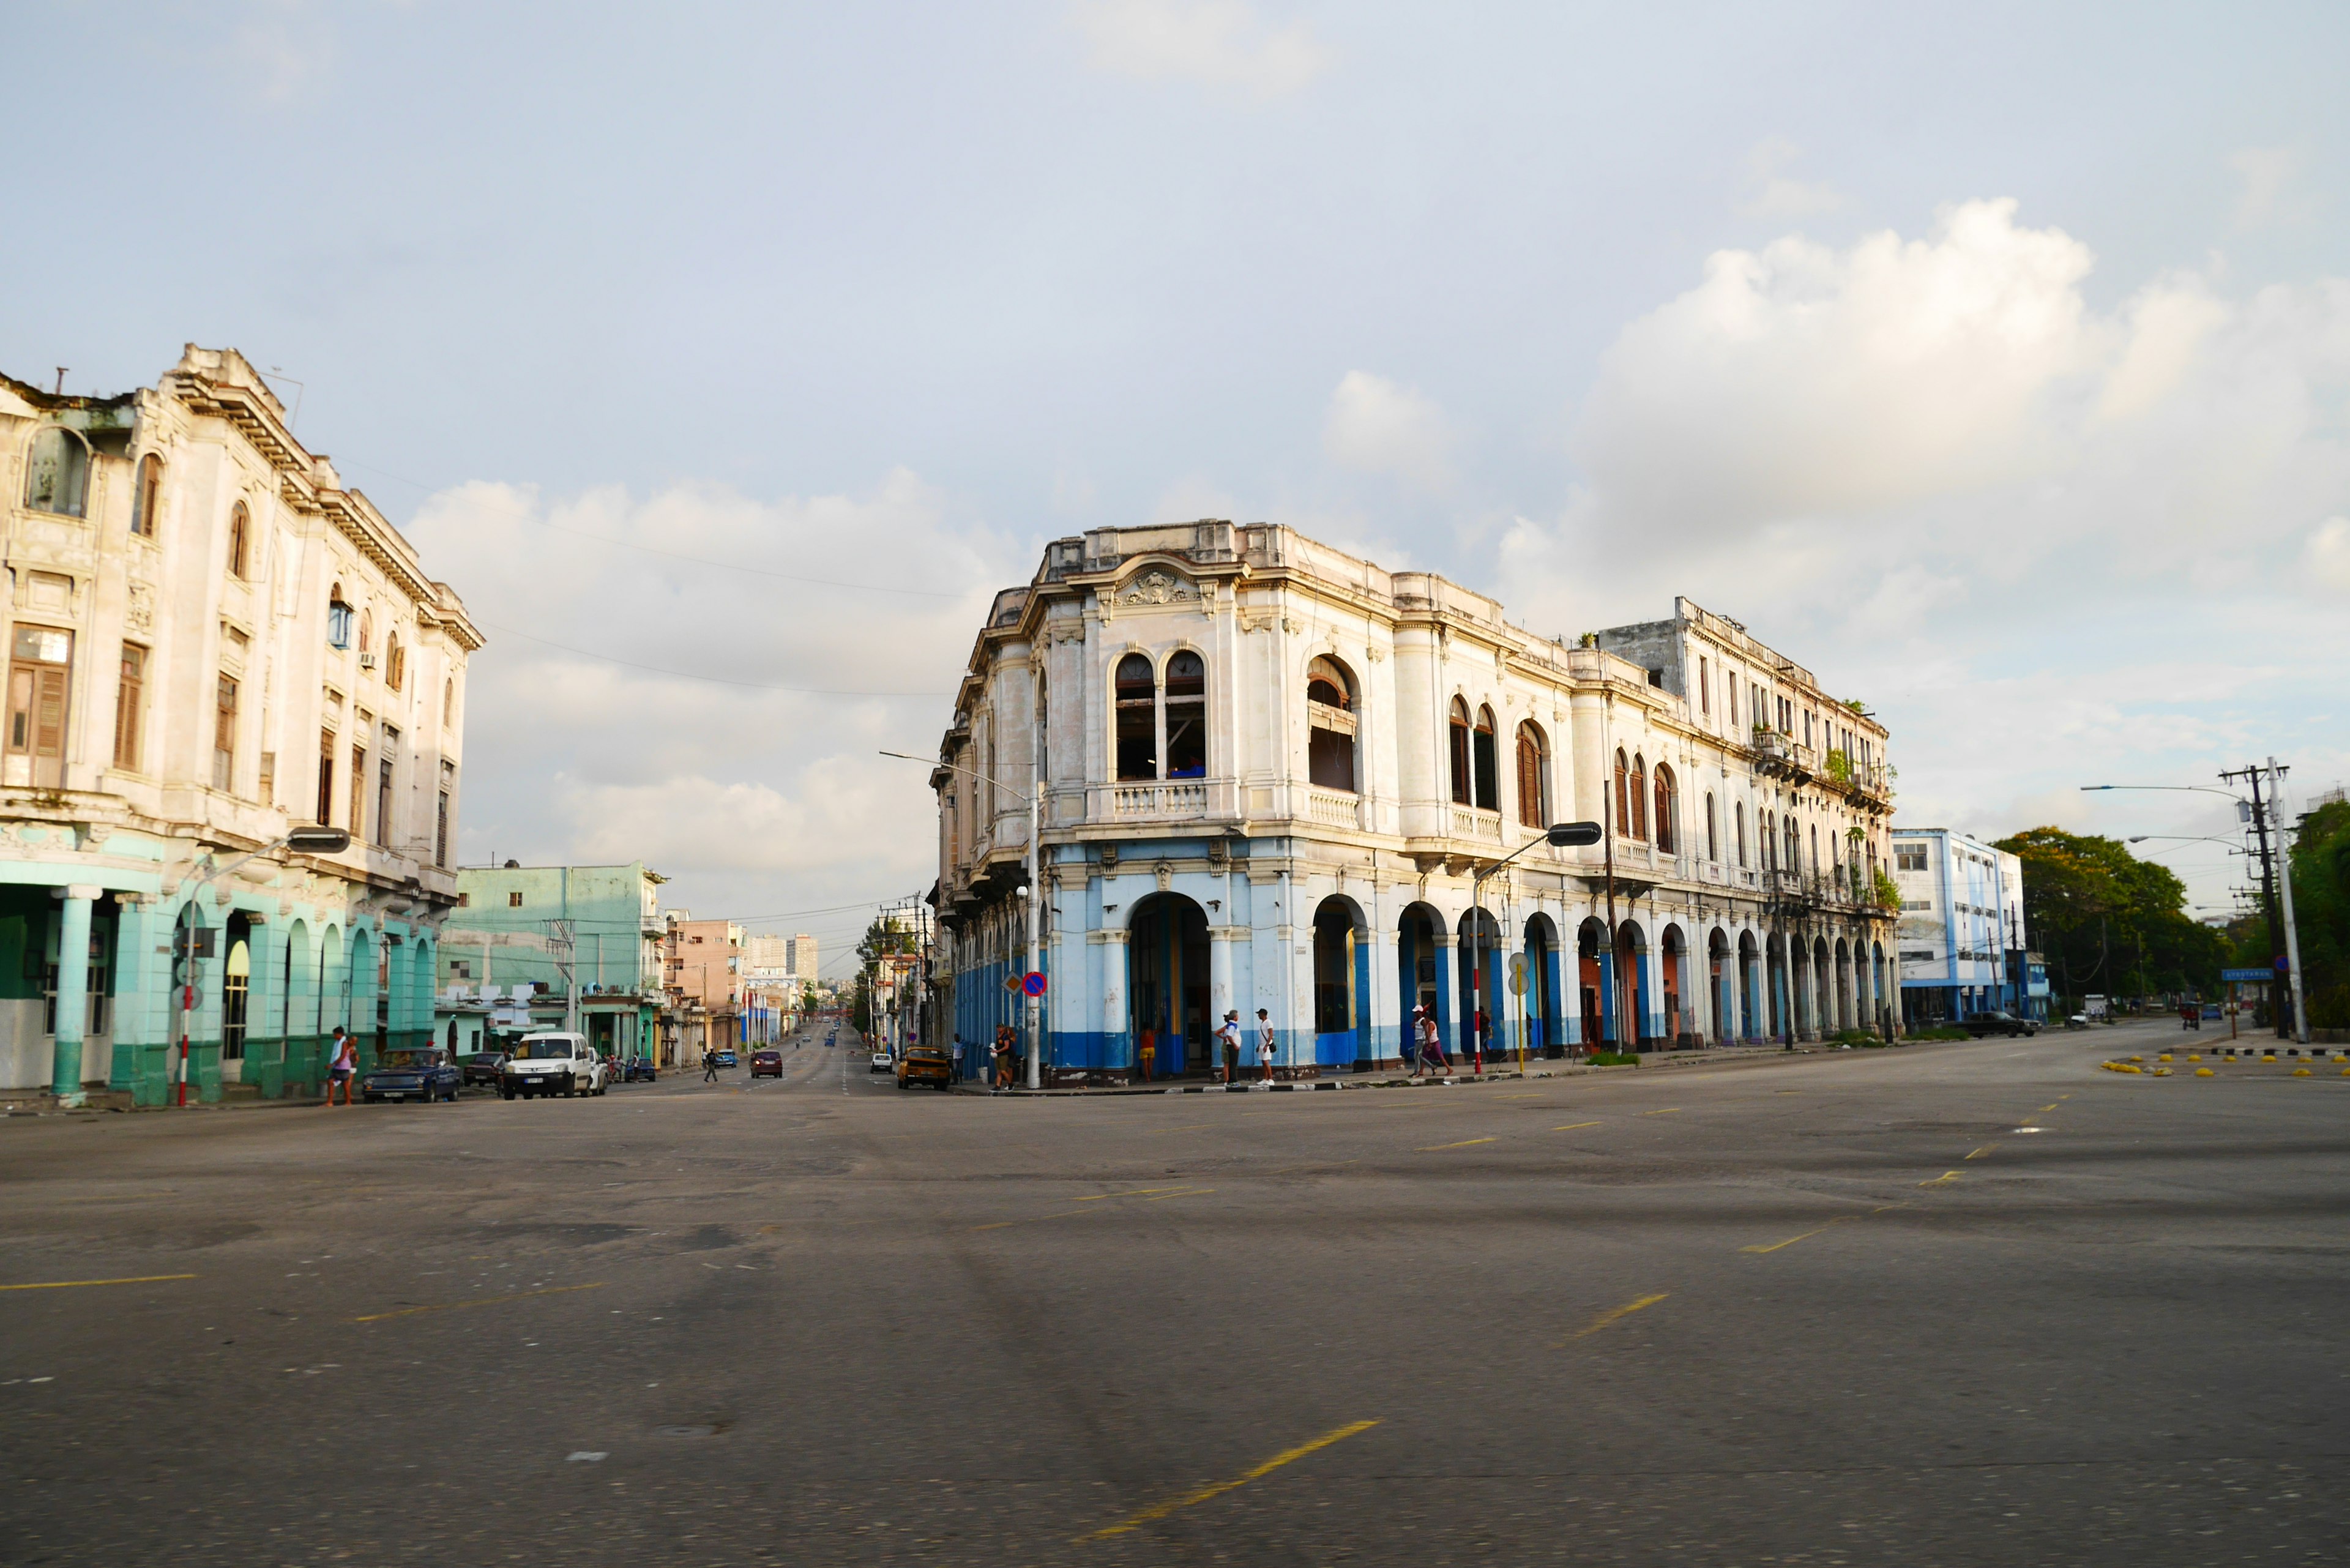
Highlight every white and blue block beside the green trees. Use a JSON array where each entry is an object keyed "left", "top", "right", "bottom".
[{"left": 1894, "top": 827, "right": 2047, "bottom": 1028}]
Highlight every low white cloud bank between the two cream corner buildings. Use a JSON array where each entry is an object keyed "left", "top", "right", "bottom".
[{"left": 409, "top": 470, "right": 1029, "bottom": 909}]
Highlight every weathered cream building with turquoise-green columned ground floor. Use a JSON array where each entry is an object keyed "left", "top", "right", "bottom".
[{"left": 0, "top": 343, "right": 482, "bottom": 1105}]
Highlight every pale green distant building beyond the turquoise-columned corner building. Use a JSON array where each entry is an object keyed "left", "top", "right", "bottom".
[{"left": 435, "top": 861, "right": 668, "bottom": 1058}]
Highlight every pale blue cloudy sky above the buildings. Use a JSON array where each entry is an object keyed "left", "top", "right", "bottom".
[{"left": 0, "top": 0, "right": 2350, "bottom": 969}]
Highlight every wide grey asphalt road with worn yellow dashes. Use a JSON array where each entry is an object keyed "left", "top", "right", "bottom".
[{"left": 0, "top": 1025, "right": 2350, "bottom": 1568}]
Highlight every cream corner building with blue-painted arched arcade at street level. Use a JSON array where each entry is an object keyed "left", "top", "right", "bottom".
[{"left": 931, "top": 522, "right": 1899, "bottom": 1084}]
